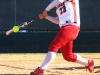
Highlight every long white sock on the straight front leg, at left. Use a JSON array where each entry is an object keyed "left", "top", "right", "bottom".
[{"left": 40, "top": 52, "right": 56, "bottom": 69}]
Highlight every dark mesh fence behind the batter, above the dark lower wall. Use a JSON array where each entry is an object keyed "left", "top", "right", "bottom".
[{"left": 0, "top": 0, "right": 100, "bottom": 31}]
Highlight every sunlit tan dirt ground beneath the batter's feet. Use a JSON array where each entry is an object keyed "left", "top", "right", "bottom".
[{"left": 0, "top": 53, "right": 100, "bottom": 75}]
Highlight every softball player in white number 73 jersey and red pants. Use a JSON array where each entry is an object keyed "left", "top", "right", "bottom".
[{"left": 30, "top": 0, "right": 94, "bottom": 75}]
